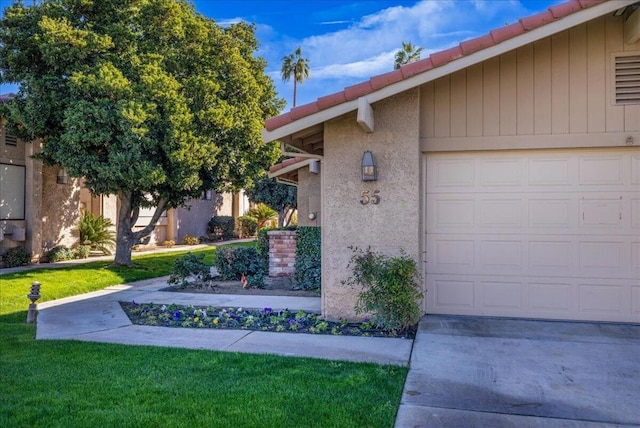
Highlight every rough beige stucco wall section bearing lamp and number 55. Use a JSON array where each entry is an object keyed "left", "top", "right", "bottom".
[{"left": 322, "top": 89, "right": 421, "bottom": 319}]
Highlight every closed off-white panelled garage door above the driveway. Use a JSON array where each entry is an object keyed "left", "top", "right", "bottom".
[{"left": 424, "top": 148, "right": 640, "bottom": 322}]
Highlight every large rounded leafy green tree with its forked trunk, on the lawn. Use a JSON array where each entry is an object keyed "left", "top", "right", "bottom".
[{"left": 0, "top": 0, "right": 284, "bottom": 265}]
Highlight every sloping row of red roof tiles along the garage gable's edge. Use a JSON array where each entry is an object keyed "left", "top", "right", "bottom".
[{"left": 265, "top": 0, "right": 608, "bottom": 133}]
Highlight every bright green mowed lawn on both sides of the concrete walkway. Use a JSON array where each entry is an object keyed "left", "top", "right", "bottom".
[{"left": 0, "top": 242, "right": 407, "bottom": 427}]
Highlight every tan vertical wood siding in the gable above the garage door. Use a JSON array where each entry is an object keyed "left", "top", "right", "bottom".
[{"left": 420, "top": 15, "right": 640, "bottom": 138}]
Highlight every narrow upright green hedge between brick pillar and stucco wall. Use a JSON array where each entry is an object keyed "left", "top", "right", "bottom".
[{"left": 294, "top": 226, "right": 322, "bottom": 290}]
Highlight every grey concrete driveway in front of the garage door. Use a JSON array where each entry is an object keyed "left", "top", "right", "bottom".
[{"left": 396, "top": 316, "right": 640, "bottom": 428}]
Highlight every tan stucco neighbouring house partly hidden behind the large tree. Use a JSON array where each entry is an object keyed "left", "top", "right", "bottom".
[{"left": 0, "top": 94, "right": 249, "bottom": 261}]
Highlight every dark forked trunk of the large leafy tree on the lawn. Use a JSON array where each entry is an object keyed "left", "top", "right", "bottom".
[{"left": 113, "top": 192, "right": 167, "bottom": 266}]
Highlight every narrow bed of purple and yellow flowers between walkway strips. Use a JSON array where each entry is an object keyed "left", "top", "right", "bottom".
[{"left": 119, "top": 301, "right": 416, "bottom": 339}]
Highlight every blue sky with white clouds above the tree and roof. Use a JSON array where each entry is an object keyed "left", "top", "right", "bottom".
[{"left": 0, "top": 0, "right": 563, "bottom": 110}]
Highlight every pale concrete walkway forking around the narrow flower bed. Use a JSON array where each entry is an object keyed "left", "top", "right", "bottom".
[{"left": 36, "top": 277, "right": 413, "bottom": 366}]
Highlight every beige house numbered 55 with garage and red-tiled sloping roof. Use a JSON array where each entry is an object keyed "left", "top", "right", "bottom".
[{"left": 263, "top": 0, "right": 640, "bottom": 323}]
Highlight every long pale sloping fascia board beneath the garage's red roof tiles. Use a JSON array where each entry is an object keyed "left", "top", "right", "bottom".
[{"left": 262, "top": 0, "right": 635, "bottom": 142}]
